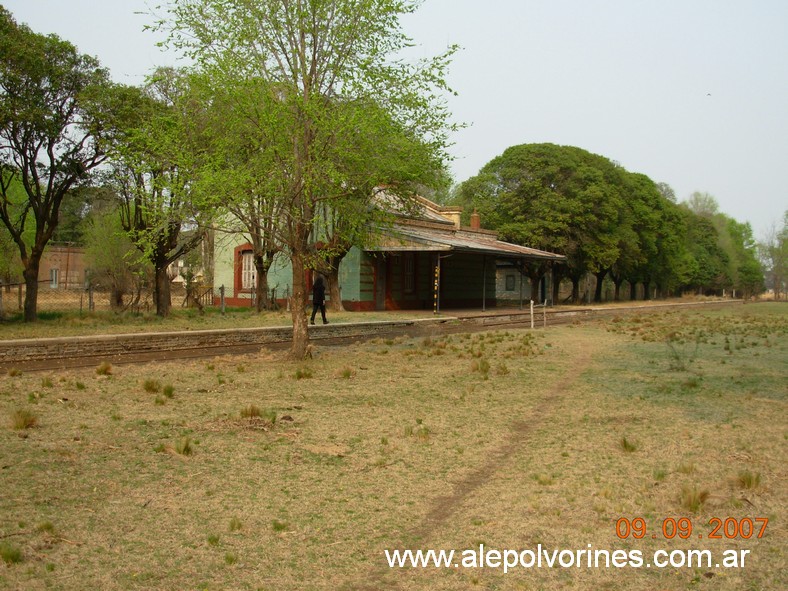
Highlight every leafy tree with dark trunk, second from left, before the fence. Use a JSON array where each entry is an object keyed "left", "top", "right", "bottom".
[{"left": 110, "top": 69, "right": 205, "bottom": 316}]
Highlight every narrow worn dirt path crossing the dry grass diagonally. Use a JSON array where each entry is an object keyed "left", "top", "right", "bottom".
[{"left": 342, "top": 347, "right": 592, "bottom": 591}]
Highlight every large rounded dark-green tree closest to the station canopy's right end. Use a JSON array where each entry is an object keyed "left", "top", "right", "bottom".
[{"left": 457, "top": 144, "right": 629, "bottom": 302}]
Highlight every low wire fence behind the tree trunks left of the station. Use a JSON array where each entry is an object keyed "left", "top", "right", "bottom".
[{"left": 0, "top": 281, "right": 218, "bottom": 317}]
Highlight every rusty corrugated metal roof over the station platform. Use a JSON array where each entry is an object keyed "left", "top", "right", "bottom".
[{"left": 369, "top": 224, "right": 566, "bottom": 261}]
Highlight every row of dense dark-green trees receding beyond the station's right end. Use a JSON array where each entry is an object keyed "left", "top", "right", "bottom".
[{"left": 454, "top": 144, "right": 763, "bottom": 301}]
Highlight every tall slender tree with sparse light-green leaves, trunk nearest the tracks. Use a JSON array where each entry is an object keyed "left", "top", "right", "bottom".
[{"left": 161, "top": 0, "right": 454, "bottom": 357}]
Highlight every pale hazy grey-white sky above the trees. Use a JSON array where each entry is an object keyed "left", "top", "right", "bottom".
[{"left": 0, "top": 0, "right": 788, "bottom": 237}]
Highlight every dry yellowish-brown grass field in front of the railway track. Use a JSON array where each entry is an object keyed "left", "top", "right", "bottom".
[{"left": 0, "top": 304, "right": 788, "bottom": 591}]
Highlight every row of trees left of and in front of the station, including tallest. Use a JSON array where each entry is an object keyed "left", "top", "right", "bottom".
[{"left": 0, "top": 0, "right": 454, "bottom": 357}]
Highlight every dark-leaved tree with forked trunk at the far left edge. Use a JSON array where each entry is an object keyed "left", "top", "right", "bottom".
[{"left": 0, "top": 6, "right": 120, "bottom": 322}]
